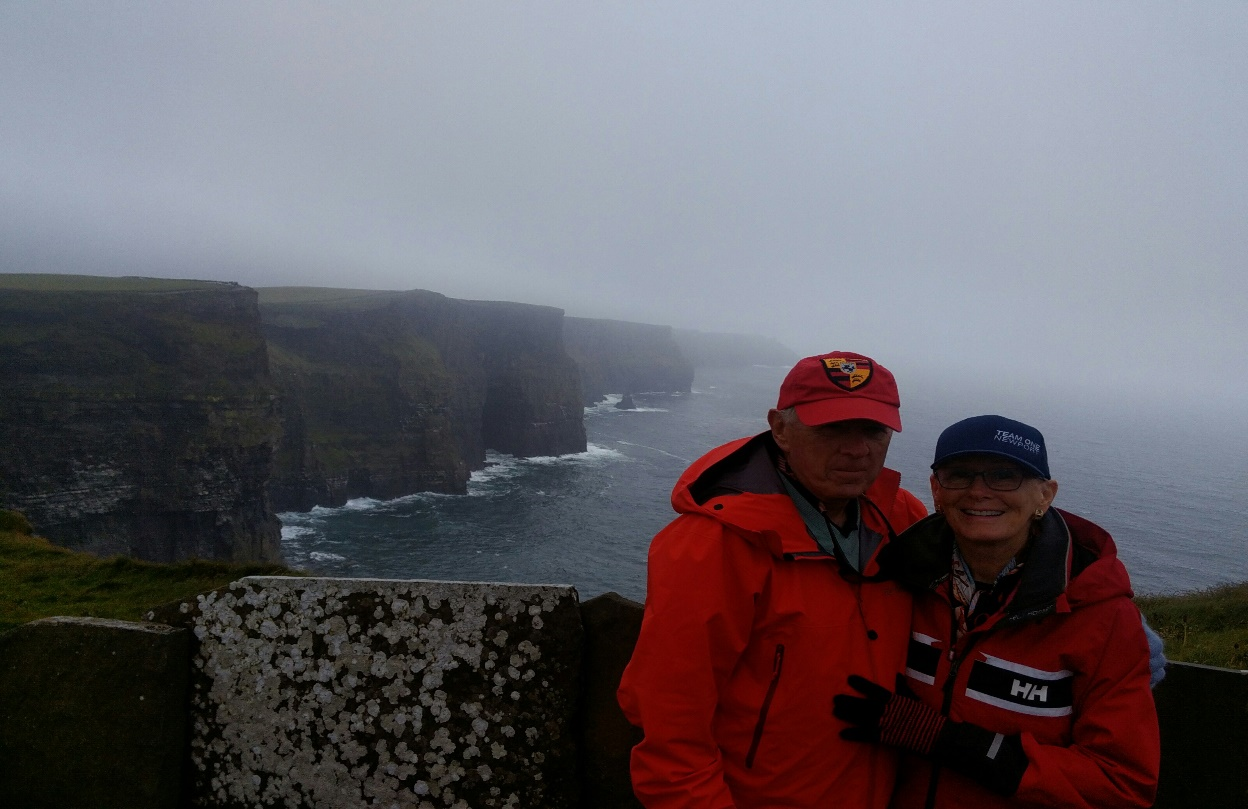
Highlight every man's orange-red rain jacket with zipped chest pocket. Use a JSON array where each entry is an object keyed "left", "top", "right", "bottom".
[{"left": 619, "top": 433, "right": 926, "bottom": 809}]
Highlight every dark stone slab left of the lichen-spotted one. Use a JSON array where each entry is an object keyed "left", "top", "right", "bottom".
[{"left": 0, "top": 618, "right": 190, "bottom": 809}]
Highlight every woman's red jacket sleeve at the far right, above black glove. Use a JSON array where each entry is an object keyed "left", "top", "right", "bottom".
[{"left": 1015, "top": 598, "right": 1161, "bottom": 809}]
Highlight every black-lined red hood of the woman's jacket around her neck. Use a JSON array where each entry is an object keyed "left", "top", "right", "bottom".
[{"left": 880, "top": 508, "right": 1132, "bottom": 622}]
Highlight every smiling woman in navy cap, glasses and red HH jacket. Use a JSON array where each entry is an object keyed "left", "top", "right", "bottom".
[{"left": 834, "top": 416, "right": 1161, "bottom": 809}]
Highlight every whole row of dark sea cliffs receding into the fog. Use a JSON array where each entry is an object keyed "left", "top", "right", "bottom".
[{"left": 0, "top": 275, "right": 788, "bottom": 562}]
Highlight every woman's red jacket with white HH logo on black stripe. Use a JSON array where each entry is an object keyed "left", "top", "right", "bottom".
[{"left": 893, "top": 508, "right": 1161, "bottom": 809}]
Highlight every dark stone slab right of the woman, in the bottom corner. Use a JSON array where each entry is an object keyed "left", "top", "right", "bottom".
[{"left": 1153, "top": 663, "right": 1248, "bottom": 809}]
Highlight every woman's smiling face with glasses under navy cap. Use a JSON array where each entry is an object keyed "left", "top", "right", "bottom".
[{"left": 931, "top": 454, "right": 1057, "bottom": 552}]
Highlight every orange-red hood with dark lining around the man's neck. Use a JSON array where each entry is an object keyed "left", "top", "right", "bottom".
[{"left": 671, "top": 432, "right": 901, "bottom": 576}]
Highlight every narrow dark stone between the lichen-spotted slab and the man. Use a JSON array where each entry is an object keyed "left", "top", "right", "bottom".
[{"left": 580, "top": 593, "right": 643, "bottom": 809}]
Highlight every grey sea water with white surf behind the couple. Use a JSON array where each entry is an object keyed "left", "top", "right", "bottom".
[{"left": 281, "top": 367, "right": 1248, "bottom": 601}]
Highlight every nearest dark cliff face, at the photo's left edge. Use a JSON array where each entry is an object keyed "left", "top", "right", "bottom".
[{"left": 0, "top": 276, "right": 281, "bottom": 562}]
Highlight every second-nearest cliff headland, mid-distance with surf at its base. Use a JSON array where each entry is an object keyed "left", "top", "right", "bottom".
[{"left": 261, "top": 288, "right": 585, "bottom": 511}]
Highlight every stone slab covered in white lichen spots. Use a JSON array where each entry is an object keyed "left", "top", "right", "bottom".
[{"left": 173, "top": 577, "right": 582, "bottom": 809}]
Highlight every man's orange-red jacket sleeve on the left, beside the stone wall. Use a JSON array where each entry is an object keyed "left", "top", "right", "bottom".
[{"left": 618, "top": 514, "right": 765, "bottom": 809}]
